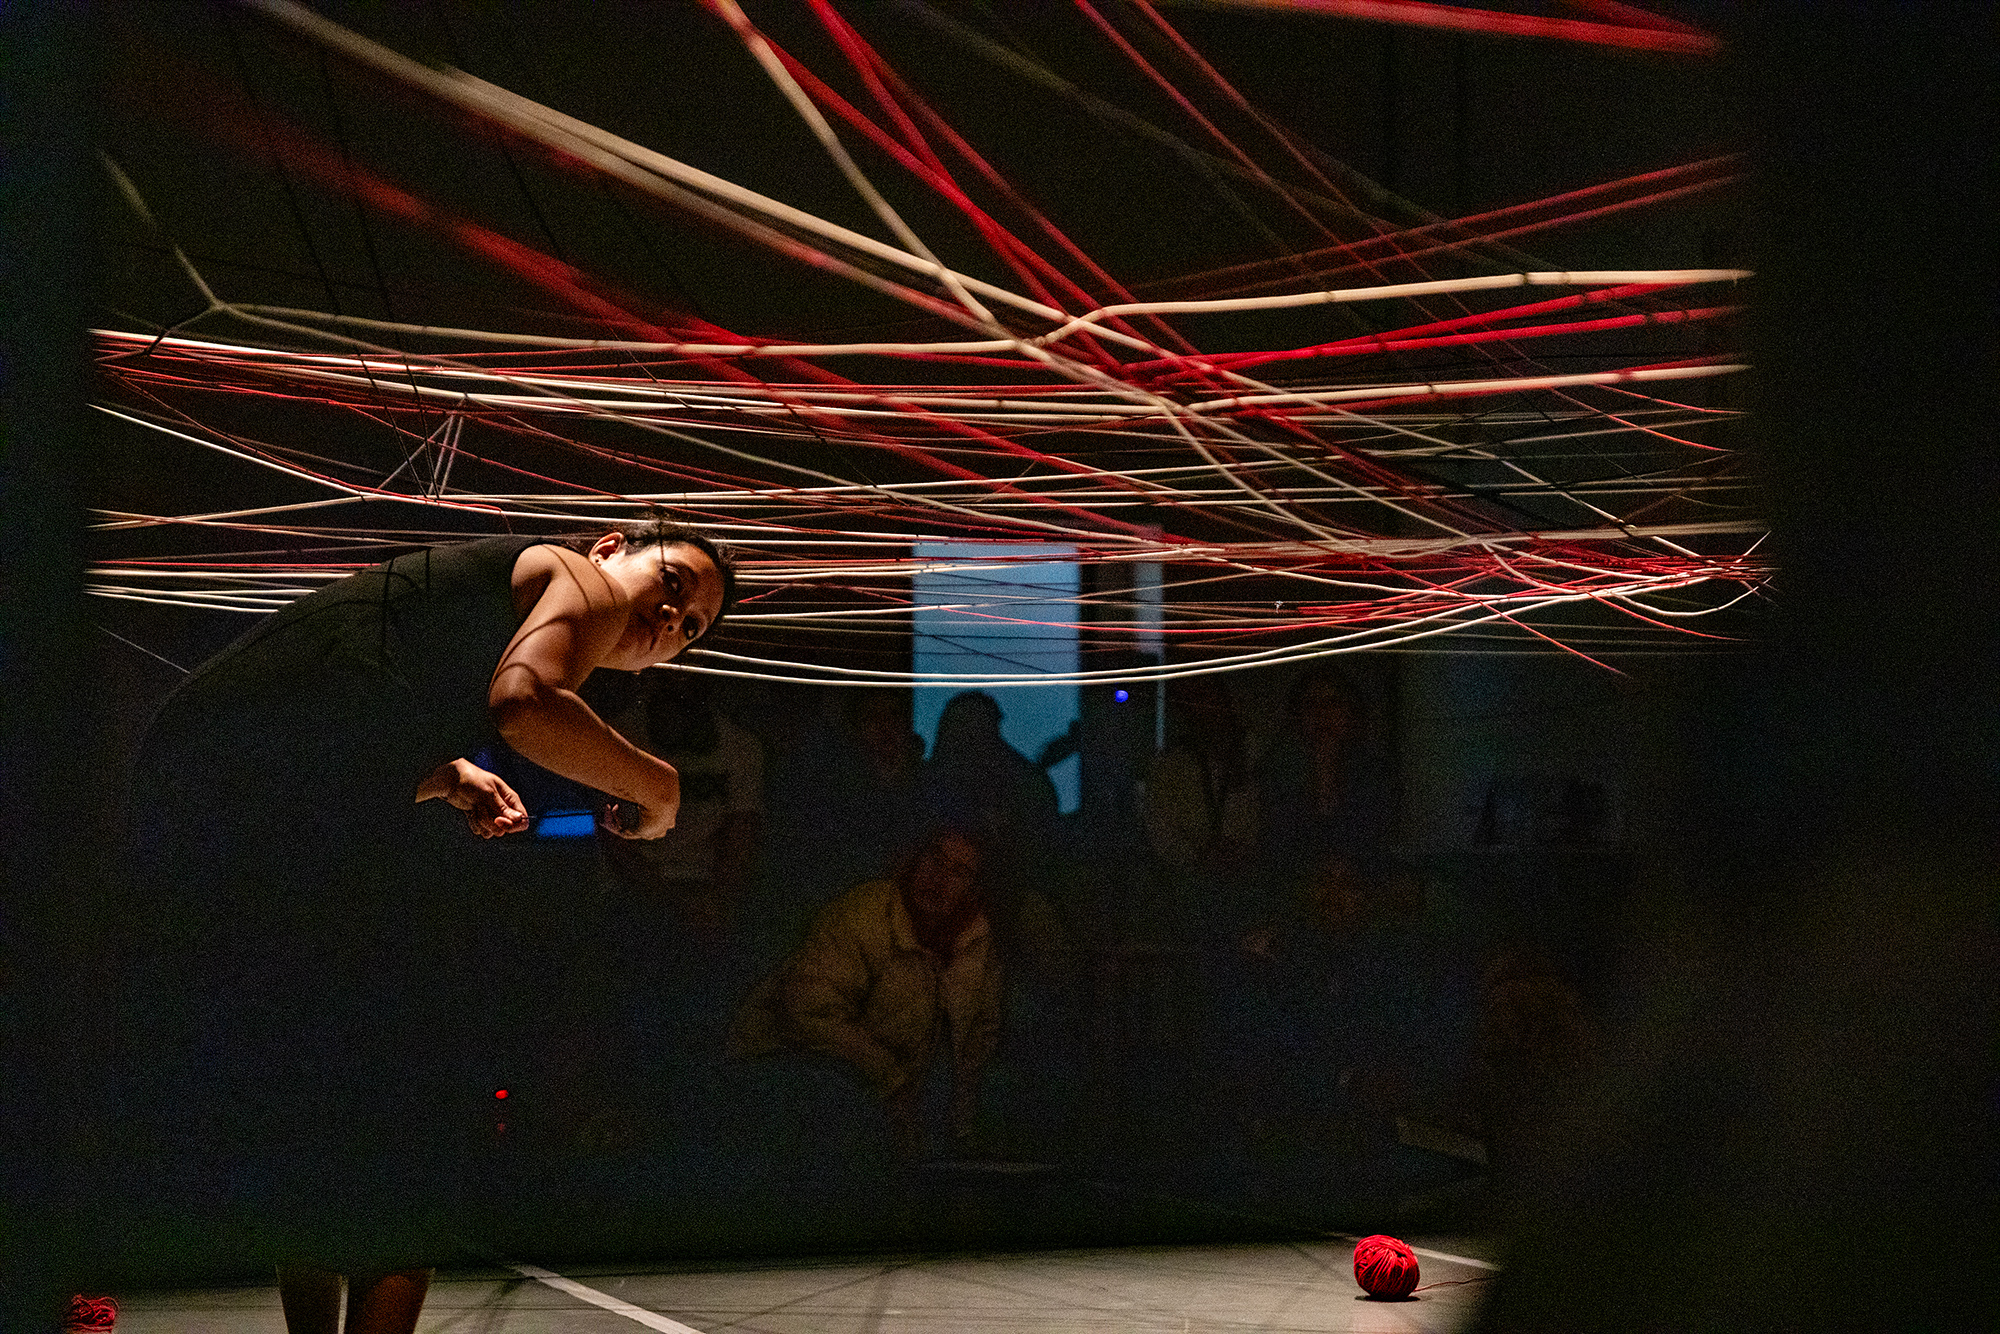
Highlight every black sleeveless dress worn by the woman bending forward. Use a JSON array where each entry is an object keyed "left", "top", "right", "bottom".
[{"left": 126, "top": 538, "right": 556, "bottom": 1270}]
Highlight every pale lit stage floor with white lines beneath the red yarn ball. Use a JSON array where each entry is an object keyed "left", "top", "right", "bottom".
[{"left": 105, "top": 1236, "right": 1496, "bottom": 1334}]
